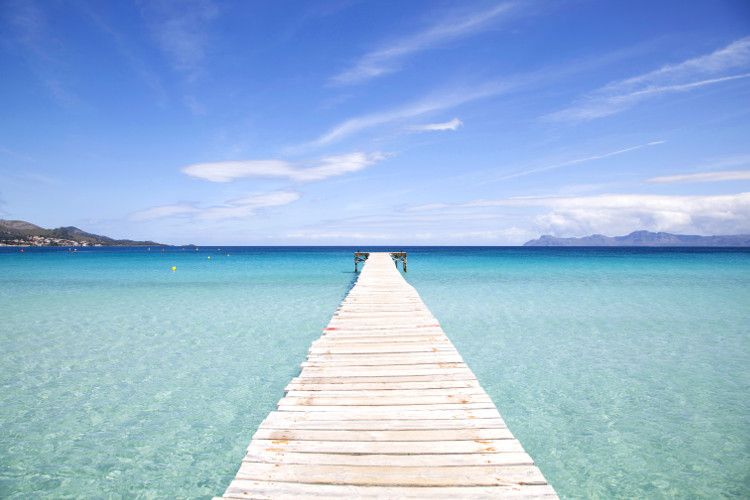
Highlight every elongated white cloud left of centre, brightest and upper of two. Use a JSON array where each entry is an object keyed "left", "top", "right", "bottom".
[{"left": 182, "top": 152, "right": 386, "bottom": 182}]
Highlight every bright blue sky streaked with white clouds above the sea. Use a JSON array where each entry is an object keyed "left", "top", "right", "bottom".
[{"left": 0, "top": 0, "right": 750, "bottom": 245}]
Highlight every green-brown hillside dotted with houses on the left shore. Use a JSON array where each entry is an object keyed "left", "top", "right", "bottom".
[{"left": 0, "top": 219, "right": 161, "bottom": 246}]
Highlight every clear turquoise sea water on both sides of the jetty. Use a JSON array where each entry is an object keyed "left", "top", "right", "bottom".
[{"left": 0, "top": 248, "right": 750, "bottom": 498}]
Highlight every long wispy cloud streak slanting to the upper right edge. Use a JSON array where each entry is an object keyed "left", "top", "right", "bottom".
[{"left": 545, "top": 37, "right": 750, "bottom": 121}]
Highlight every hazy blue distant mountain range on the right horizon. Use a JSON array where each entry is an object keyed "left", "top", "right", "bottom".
[{"left": 523, "top": 231, "right": 750, "bottom": 247}]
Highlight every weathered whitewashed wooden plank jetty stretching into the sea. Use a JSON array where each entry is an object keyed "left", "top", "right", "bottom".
[{"left": 217, "top": 253, "right": 556, "bottom": 499}]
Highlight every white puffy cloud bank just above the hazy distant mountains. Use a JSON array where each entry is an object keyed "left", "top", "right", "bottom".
[{"left": 419, "top": 193, "right": 750, "bottom": 236}]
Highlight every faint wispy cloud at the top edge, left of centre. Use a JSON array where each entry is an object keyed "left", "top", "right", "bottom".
[{"left": 142, "top": 0, "right": 219, "bottom": 79}]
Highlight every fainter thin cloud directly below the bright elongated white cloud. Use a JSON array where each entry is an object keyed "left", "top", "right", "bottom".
[{"left": 130, "top": 191, "right": 300, "bottom": 221}]
